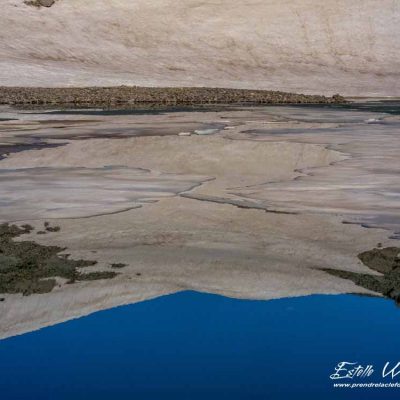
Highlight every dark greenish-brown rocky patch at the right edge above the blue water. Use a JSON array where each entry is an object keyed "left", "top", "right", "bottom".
[{"left": 323, "top": 247, "right": 400, "bottom": 304}]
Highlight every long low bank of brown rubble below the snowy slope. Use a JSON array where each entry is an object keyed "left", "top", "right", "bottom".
[{"left": 0, "top": 86, "right": 346, "bottom": 106}]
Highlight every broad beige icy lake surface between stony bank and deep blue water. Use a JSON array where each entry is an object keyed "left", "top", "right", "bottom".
[{"left": 0, "top": 106, "right": 400, "bottom": 337}]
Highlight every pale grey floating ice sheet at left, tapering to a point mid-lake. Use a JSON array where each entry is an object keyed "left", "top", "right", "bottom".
[{"left": 0, "top": 166, "right": 208, "bottom": 222}]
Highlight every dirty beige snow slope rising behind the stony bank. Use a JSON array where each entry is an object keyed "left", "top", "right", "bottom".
[{"left": 0, "top": 0, "right": 400, "bottom": 96}]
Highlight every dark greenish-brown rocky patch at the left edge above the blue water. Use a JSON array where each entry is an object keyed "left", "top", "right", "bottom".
[{"left": 0, "top": 224, "right": 117, "bottom": 296}]
